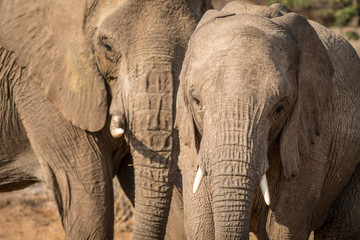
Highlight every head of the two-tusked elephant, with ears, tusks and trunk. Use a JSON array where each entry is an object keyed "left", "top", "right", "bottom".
[{"left": 176, "top": 2, "right": 333, "bottom": 239}]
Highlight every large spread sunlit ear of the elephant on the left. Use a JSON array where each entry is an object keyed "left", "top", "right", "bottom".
[{"left": 0, "top": 0, "right": 108, "bottom": 131}]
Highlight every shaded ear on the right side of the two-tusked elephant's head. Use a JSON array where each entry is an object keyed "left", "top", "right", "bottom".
[{"left": 273, "top": 13, "right": 334, "bottom": 179}]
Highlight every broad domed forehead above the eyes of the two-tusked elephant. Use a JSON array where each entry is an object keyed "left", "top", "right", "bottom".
[{"left": 185, "top": 15, "right": 299, "bottom": 99}]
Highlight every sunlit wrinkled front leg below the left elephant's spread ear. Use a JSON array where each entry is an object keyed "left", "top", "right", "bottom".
[{"left": 14, "top": 81, "right": 114, "bottom": 239}]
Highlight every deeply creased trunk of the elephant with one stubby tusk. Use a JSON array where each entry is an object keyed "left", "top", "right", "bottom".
[{"left": 127, "top": 67, "right": 177, "bottom": 239}]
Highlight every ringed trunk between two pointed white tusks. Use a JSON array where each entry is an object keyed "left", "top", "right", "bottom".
[{"left": 207, "top": 99, "right": 267, "bottom": 239}]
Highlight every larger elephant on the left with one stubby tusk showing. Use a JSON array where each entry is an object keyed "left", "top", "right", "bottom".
[{"left": 0, "top": 0, "right": 224, "bottom": 239}]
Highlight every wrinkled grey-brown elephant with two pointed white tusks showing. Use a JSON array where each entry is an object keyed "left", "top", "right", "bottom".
[{"left": 176, "top": 2, "right": 360, "bottom": 239}]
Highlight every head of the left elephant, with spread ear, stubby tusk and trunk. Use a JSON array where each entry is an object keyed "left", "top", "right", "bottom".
[{"left": 0, "top": 0, "right": 217, "bottom": 238}]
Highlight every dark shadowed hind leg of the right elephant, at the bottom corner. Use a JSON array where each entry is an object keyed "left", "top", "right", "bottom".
[{"left": 315, "top": 164, "right": 360, "bottom": 240}]
